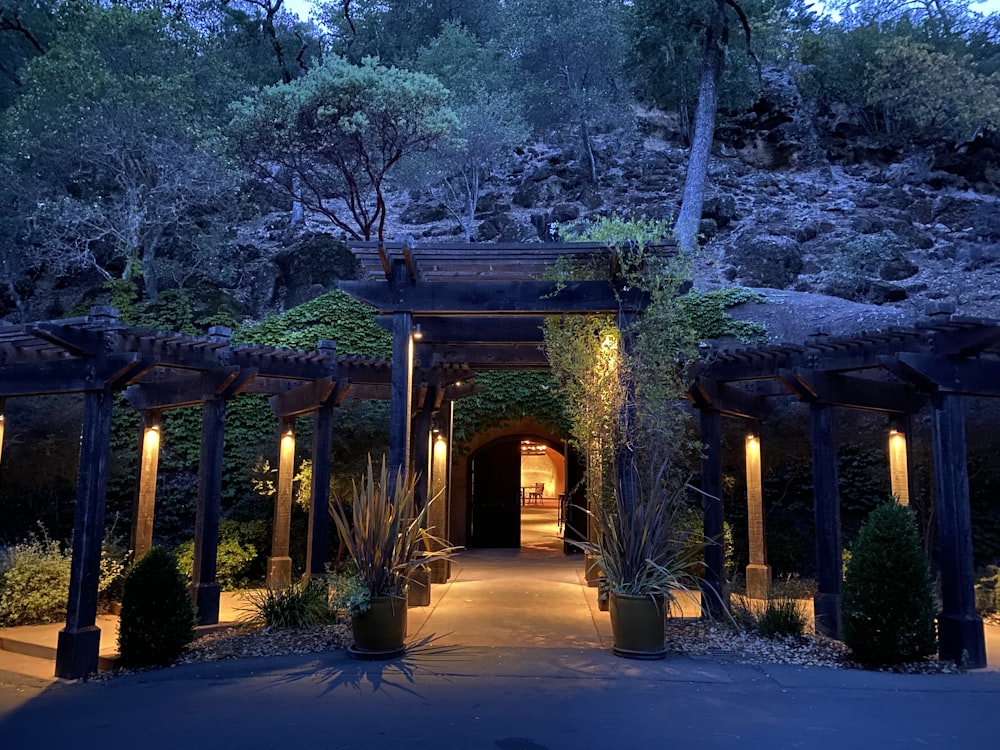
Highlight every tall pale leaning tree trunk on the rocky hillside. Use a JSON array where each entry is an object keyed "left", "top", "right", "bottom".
[{"left": 674, "top": 0, "right": 729, "bottom": 255}]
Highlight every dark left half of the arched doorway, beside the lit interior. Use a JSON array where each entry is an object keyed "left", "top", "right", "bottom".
[{"left": 467, "top": 439, "right": 521, "bottom": 547}]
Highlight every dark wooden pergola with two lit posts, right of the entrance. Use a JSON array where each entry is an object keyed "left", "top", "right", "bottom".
[{"left": 688, "top": 316, "right": 1000, "bottom": 667}]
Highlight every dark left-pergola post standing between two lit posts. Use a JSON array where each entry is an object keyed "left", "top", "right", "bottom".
[{"left": 191, "top": 396, "right": 226, "bottom": 625}]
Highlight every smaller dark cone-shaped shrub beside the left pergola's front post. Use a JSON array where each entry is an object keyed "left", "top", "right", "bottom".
[{"left": 118, "top": 547, "right": 195, "bottom": 667}]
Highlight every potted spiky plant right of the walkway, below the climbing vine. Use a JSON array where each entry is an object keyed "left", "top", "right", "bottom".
[{"left": 574, "top": 473, "right": 705, "bottom": 659}]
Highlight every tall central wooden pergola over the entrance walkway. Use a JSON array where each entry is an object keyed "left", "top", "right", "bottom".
[{"left": 340, "top": 242, "right": 648, "bottom": 494}]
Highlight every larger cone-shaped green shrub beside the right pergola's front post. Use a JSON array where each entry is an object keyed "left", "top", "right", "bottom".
[{"left": 842, "top": 503, "right": 937, "bottom": 664}]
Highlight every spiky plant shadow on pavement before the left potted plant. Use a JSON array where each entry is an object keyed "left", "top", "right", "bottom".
[{"left": 270, "top": 633, "right": 468, "bottom": 698}]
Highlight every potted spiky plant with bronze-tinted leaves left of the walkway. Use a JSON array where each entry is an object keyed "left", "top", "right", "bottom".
[{"left": 330, "top": 456, "right": 455, "bottom": 659}]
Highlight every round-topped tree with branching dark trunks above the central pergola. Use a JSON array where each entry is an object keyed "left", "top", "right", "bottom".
[{"left": 231, "top": 57, "right": 455, "bottom": 240}]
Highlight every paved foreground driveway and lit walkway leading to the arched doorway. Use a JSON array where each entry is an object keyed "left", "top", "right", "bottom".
[{"left": 0, "top": 508, "right": 1000, "bottom": 750}]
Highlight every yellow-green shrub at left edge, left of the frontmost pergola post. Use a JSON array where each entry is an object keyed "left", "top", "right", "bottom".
[{"left": 0, "top": 535, "right": 70, "bottom": 626}]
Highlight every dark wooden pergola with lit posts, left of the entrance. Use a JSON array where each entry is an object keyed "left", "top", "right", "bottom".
[{"left": 0, "top": 307, "right": 473, "bottom": 678}]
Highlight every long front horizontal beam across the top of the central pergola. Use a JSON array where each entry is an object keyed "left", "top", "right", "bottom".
[{"left": 339, "top": 281, "right": 649, "bottom": 315}]
